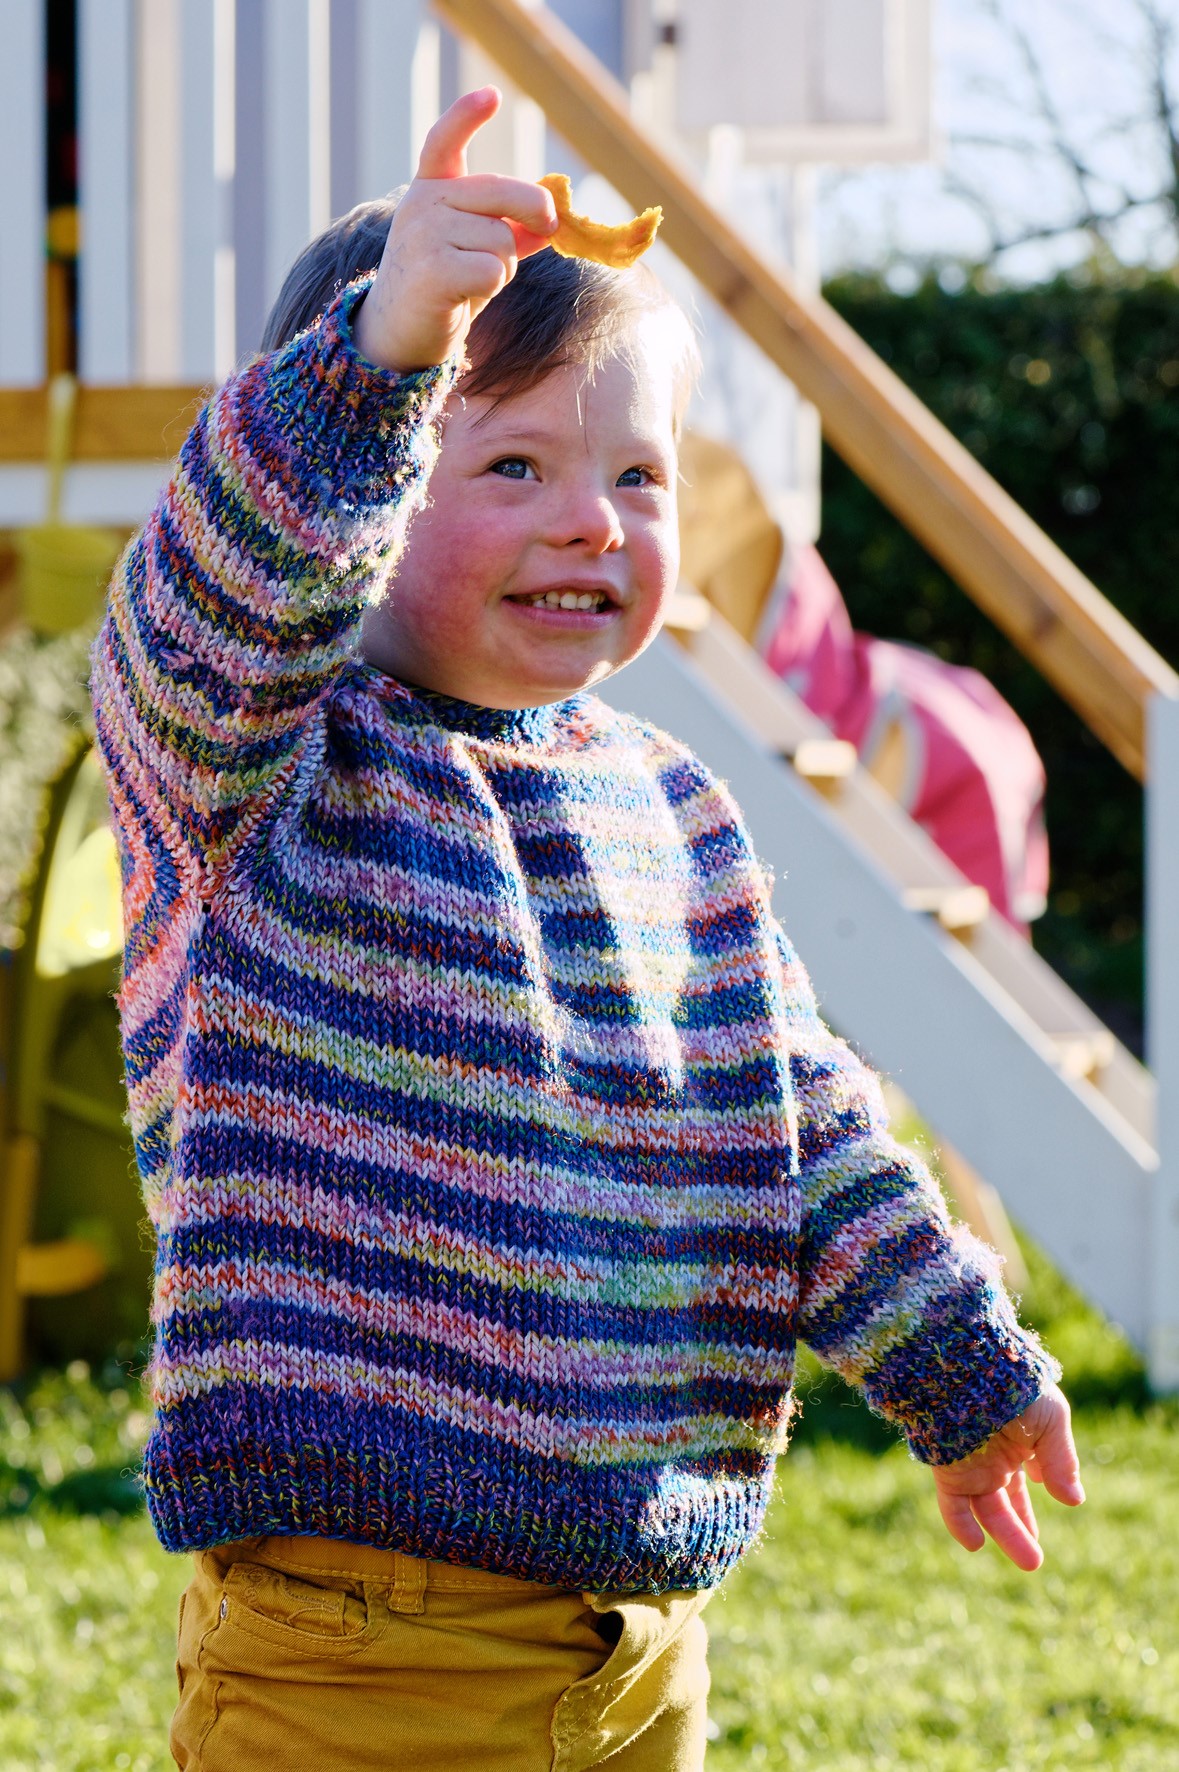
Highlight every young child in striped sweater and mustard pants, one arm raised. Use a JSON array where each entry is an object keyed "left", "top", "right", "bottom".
[{"left": 94, "top": 89, "right": 1081, "bottom": 1772}]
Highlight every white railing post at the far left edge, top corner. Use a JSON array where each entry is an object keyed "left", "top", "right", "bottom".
[{"left": 0, "top": 0, "right": 44, "bottom": 388}]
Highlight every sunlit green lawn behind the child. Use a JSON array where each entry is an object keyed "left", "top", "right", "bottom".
[{"left": 0, "top": 1258, "right": 1179, "bottom": 1772}]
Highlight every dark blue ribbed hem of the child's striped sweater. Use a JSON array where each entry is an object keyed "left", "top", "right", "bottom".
[{"left": 144, "top": 1398, "right": 769, "bottom": 1593}]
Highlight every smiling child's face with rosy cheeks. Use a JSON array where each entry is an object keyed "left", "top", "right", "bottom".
[{"left": 363, "top": 315, "right": 679, "bottom": 707}]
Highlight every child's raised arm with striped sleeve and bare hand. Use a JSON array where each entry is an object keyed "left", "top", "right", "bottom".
[{"left": 92, "top": 89, "right": 555, "bottom": 870}]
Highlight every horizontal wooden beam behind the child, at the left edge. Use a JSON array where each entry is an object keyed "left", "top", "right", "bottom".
[{"left": 0, "top": 386, "right": 206, "bottom": 462}]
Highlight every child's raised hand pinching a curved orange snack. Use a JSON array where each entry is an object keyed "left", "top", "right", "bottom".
[{"left": 356, "top": 87, "right": 557, "bottom": 370}]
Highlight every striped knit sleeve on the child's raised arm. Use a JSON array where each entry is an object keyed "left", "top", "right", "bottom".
[{"left": 92, "top": 282, "right": 454, "bottom": 868}]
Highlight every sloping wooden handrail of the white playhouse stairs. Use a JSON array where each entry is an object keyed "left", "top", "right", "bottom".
[{"left": 433, "top": 0, "right": 1179, "bottom": 780}]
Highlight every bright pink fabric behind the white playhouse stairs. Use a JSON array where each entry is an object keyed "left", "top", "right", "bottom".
[{"left": 762, "top": 548, "right": 1048, "bottom": 927}]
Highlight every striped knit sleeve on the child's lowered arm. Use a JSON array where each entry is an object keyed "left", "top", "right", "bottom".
[{"left": 778, "top": 934, "right": 1060, "bottom": 1464}]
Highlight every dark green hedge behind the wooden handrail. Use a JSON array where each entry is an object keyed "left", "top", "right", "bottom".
[{"left": 821, "top": 265, "right": 1179, "bottom": 1044}]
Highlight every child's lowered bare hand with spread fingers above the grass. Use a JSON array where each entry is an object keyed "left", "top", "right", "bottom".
[{"left": 931, "top": 1384, "right": 1085, "bottom": 1572}]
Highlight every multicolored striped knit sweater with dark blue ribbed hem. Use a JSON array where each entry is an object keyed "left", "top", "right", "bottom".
[{"left": 94, "top": 279, "right": 1055, "bottom": 1591}]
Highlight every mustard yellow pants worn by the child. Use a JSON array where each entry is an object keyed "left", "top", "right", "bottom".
[{"left": 172, "top": 1538, "right": 707, "bottom": 1772}]
